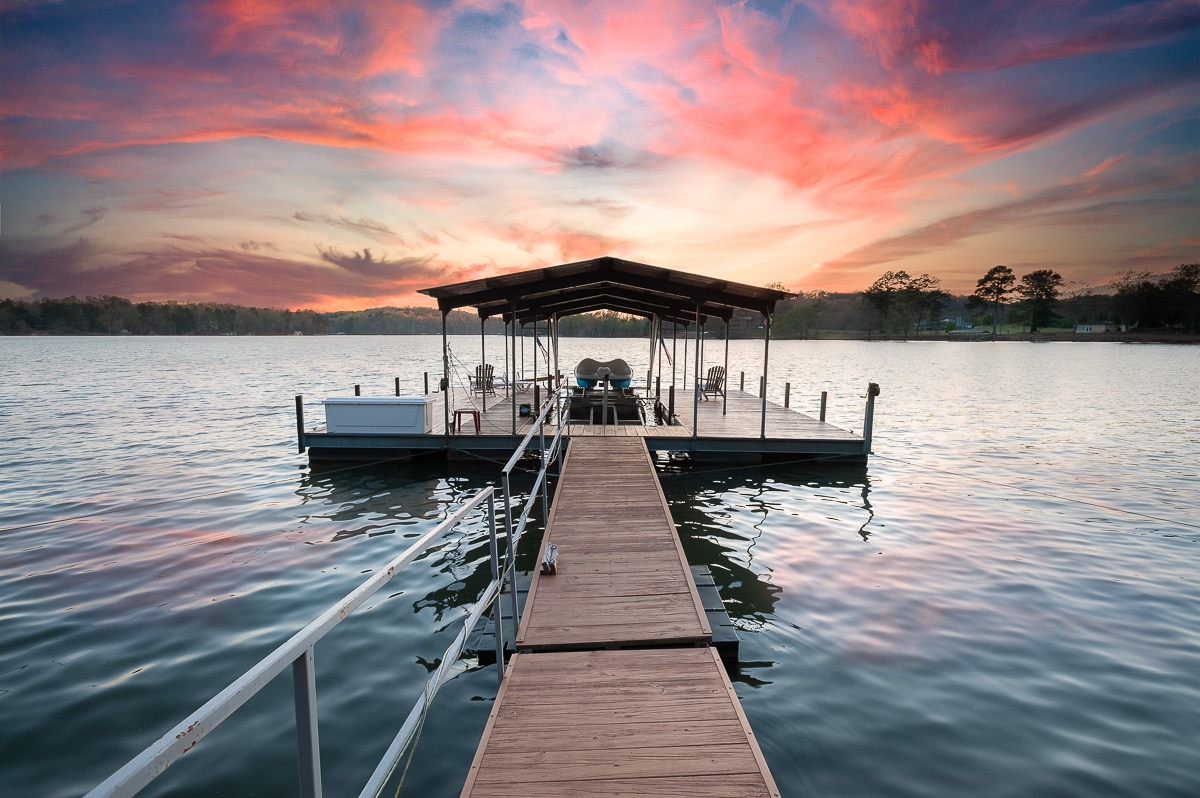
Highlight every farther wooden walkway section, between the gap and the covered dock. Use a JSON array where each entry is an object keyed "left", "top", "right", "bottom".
[{"left": 516, "top": 437, "right": 713, "bottom": 650}]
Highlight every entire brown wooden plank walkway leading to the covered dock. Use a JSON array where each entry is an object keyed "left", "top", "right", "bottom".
[{"left": 462, "top": 437, "right": 779, "bottom": 798}]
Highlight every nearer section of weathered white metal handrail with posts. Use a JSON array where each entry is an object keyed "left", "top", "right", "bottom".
[{"left": 85, "top": 487, "right": 496, "bottom": 798}]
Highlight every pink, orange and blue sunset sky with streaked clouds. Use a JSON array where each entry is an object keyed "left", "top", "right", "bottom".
[{"left": 0, "top": 0, "right": 1200, "bottom": 310}]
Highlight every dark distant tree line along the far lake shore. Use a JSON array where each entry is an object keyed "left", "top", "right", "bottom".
[{"left": 0, "top": 263, "right": 1200, "bottom": 338}]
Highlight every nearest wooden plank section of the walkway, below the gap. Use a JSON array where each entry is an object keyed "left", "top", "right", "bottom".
[{"left": 462, "top": 648, "right": 779, "bottom": 798}]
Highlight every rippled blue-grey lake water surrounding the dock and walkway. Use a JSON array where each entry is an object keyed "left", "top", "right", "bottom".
[{"left": 0, "top": 336, "right": 1200, "bottom": 797}]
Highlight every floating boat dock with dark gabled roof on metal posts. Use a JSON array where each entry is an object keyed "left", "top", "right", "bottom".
[{"left": 296, "top": 257, "right": 878, "bottom": 462}]
